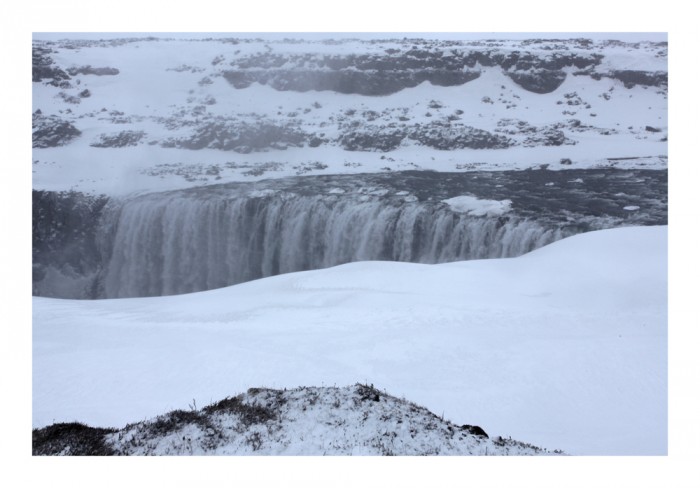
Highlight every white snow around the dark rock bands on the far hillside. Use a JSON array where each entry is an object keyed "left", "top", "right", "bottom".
[{"left": 32, "top": 40, "right": 668, "bottom": 195}]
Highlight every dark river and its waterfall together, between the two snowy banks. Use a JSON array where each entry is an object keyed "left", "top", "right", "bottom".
[{"left": 33, "top": 170, "right": 667, "bottom": 298}]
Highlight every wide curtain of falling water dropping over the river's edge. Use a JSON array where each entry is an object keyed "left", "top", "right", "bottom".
[{"left": 103, "top": 191, "right": 563, "bottom": 298}]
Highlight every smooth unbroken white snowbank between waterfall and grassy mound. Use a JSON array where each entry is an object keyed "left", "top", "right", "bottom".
[{"left": 33, "top": 226, "right": 667, "bottom": 455}]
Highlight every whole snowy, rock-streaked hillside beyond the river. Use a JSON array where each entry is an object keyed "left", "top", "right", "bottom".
[{"left": 32, "top": 36, "right": 668, "bottom": 195}]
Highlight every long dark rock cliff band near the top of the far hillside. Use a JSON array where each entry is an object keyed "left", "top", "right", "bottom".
[{"left": 224, "top": 47, "right": 602, "bottom": 96}]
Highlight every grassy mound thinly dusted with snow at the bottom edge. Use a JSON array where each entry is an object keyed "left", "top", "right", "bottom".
[{"left": 33, "top": 384, "right": 561, "bottom": 456}]
